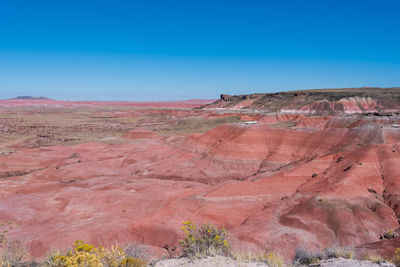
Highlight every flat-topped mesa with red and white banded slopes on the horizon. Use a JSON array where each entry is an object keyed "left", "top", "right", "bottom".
[{"left": 208, "top": 87, "right": 400, "bottom": 115}]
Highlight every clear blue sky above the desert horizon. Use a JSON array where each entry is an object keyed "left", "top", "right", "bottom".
[{"left": 0, "top": 0, "right": 400, "bottom": 100}]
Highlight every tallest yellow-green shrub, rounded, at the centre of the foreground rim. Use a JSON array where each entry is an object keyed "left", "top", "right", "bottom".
[{"left": 179, "top": 221, "right": 230, "bottom": 258}]
